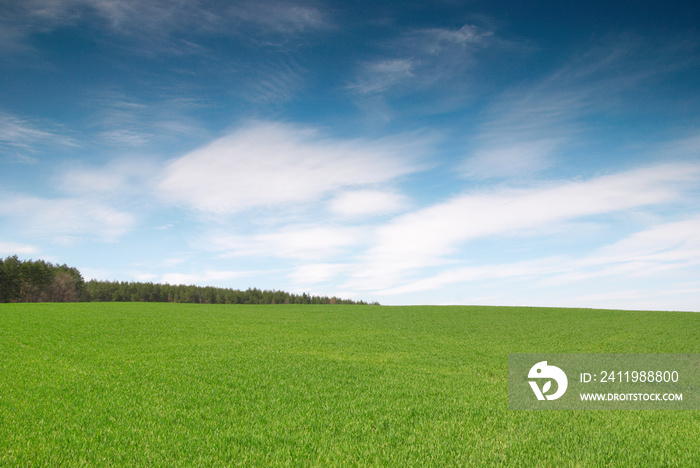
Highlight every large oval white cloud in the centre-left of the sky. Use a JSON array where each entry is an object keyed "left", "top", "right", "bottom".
[{"left": 157, "top": 123, "right": 424, "bottom": 215}]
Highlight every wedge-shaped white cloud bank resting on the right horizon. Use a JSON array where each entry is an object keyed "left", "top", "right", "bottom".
[{"left": 354, "top": 216, "right": 700, "bottom": 311}]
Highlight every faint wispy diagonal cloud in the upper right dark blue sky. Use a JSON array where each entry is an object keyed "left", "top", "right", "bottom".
[{"left": 462, "top": 36, "right": 694, "bottom": 179}]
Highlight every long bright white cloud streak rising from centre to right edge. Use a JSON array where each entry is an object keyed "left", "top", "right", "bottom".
[{"left": 346, "top": 164, "right": 700, "bottom": 290}]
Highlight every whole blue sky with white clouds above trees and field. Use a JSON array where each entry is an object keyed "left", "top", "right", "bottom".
[{"left": 0, "top": 0, "right": 700, "bottom": 311}]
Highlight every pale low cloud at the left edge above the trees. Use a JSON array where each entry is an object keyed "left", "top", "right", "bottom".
[{"left": 0, "top": 194, "right": 135, "bottom": 242}]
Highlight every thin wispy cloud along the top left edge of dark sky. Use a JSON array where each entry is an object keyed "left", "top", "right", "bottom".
[{"left": 0, "top": 0, "right": 331, "bottom": 54}]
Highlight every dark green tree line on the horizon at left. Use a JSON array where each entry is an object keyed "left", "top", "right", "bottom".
[{"left": 0, "top": 255, "right": 366, "bottom": 304}]
